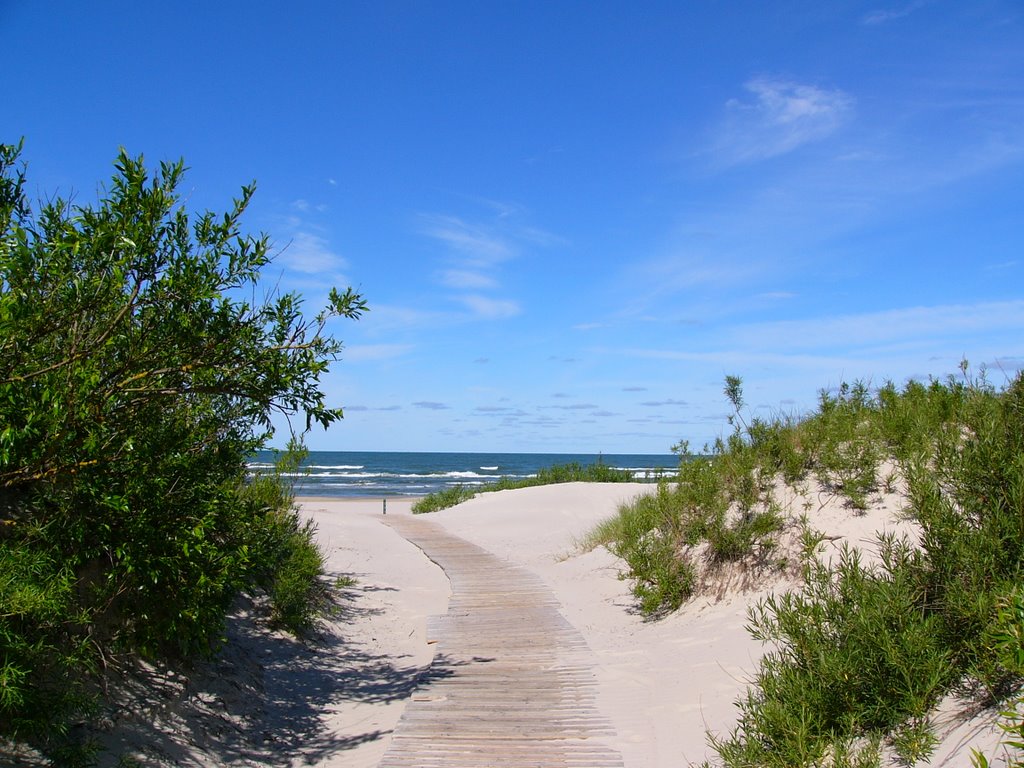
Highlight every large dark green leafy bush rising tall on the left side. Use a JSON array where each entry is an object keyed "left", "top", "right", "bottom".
[{"left": 0, "top": 145, "right": 366, "bottom": 750}]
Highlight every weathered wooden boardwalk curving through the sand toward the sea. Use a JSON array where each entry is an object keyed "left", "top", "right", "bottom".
[{"left": 379, "top": 515, "right": 623, "bottom": 768}]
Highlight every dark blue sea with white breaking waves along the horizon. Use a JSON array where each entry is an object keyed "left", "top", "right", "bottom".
[{"left": 249, "top": 451, "right": 679, "bottom": 499}]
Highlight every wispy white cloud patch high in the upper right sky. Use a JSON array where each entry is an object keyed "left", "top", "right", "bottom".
[{"left": 713, "top": 77, "right": 854, "bottom": 165}]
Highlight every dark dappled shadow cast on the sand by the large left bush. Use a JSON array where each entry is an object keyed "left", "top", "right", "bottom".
[{"left": 88, "top": 574, "right": 469, "bottom": 767}]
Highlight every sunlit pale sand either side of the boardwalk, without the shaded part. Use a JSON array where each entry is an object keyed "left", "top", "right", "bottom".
[{"left": 303, "top": 483, "right": 997, "bottom": 768}]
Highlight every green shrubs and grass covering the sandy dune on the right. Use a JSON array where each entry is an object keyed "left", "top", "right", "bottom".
[{"left": 587, "top": 366, "right": 1024, "bottom": 768}]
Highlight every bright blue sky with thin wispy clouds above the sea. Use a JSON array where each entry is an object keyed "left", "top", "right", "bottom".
[{"left": 0, "top": 0, "right": 1024, "bottom": 454}]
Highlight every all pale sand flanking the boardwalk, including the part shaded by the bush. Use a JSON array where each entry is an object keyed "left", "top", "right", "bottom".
[{"left": 86, "top": 483, "right": 1006, "bottom": 768}]
